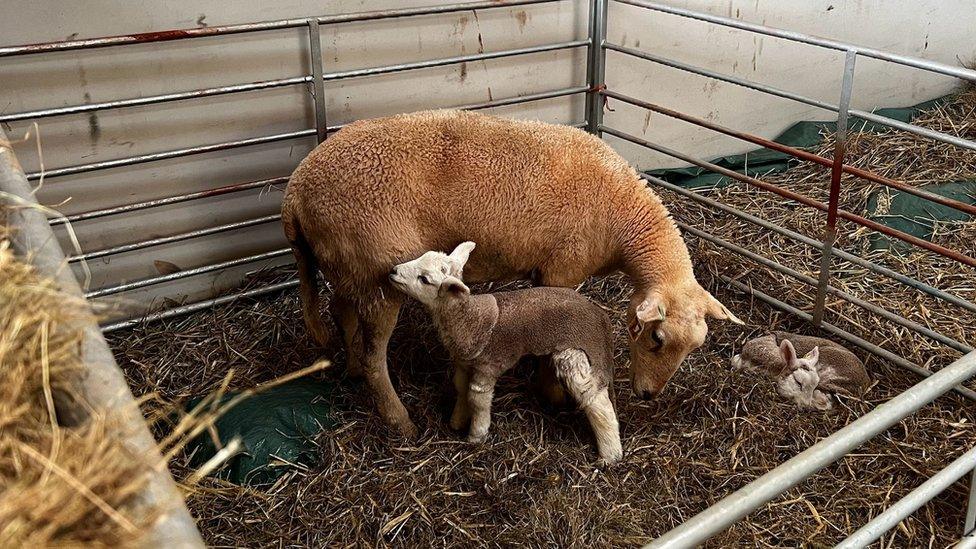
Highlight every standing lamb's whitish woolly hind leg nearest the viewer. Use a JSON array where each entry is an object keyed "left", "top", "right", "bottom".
[{"left": 552, "top": 349, "right": 623, "bottom": 464}]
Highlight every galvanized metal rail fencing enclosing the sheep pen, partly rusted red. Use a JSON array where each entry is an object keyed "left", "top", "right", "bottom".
[{"left": 0, "top": 0, "right": 976, "bottom": 547}]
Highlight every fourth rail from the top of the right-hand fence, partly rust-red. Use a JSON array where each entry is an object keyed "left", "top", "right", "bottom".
[{"left": 601, "top": 126, "right": 976, "bottom": 267}]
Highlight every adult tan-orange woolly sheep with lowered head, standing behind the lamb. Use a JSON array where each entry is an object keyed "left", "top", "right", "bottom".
[{"left": 282, "top": 110, "right": 739, "bottom": 436}]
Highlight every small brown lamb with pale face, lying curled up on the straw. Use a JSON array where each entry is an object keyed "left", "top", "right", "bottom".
[{"left": 732, "top": 332, "right": 871, "bottom": 410}]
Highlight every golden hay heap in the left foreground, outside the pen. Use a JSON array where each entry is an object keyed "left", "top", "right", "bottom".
[{"left": 0, "top": 234, "right": 155, "bottom": 547}]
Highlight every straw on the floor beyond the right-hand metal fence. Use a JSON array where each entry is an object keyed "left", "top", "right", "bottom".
[{"left": 661, "top": 88, "right": 976, "bottom": 369}]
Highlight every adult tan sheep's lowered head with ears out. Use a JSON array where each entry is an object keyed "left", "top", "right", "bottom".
[{"left": 627, "top": 281, "right": 742, "bottom": 399}]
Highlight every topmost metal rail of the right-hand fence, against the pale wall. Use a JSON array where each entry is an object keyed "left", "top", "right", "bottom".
[{"left": 615, "top": 0, "right": 976, "bottom": 82}]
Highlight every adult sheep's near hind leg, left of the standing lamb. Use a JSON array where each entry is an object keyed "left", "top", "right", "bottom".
[{"left": 359, "top": 296, "right": 418, "bottom": 438}]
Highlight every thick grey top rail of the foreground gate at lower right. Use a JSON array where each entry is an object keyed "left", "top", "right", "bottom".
[{"left": 646, "top": 352, "right": 976, "bottom": 549}]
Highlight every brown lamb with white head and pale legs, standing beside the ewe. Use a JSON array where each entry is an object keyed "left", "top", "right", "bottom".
[{"left": 390, "top": 242, "right": 623, "bottom": 463}]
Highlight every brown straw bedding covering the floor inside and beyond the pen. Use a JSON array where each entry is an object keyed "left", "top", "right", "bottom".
[{"left": 103, "top": 89, "right": 976, "bottom": 547}]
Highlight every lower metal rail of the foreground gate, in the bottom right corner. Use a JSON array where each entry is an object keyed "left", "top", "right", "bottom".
[{"left": 834, "top": 447, "right": 976, "bottom": 549}]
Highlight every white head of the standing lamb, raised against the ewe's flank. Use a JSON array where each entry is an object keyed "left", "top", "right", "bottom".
[{"left": 390, "top": 242, "right": 474, "bottom": 307}]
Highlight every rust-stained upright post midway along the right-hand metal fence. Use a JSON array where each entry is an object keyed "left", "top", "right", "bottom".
[{"left": 813, "top": 50, "right": 857, "bottom": 326}]
